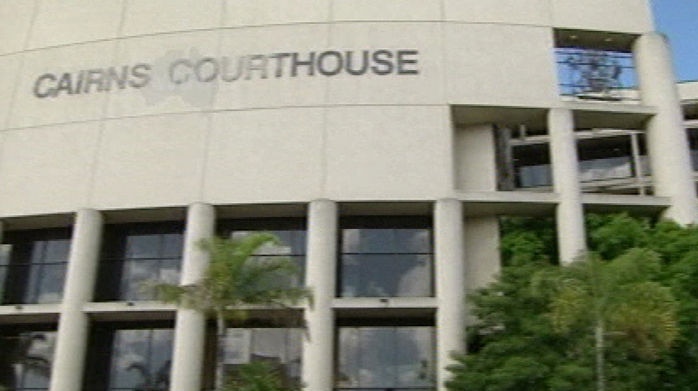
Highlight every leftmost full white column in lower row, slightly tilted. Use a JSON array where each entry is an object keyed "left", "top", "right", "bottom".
[{"left": 50, "top": 209, "right": 103, "bottom": 391}]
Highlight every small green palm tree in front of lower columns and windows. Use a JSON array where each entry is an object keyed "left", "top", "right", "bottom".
[{"left": 155, "top": 233, "right": 312, "bottom": 390}]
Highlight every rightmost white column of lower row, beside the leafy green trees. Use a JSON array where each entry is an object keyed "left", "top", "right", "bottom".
[{"left": 434, "top": 199, "right": 466, "bottom": 391}]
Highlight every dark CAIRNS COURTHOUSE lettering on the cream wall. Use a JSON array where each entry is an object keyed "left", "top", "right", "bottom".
[{"left": 33, "top": 49, "right": 419, "bottom": 99}]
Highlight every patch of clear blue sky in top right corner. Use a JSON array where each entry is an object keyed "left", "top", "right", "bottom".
[{"left": 652, "top": 0, "right": 698, "bottom": 80}]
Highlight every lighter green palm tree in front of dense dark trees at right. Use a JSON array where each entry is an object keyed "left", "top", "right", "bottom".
[{"left": 534, "top": 249, "right": 678, "bottom": 391}]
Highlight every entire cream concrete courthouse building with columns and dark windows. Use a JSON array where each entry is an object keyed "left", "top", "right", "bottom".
[{"left": 0, "top": 0, "right": 698, "bottom": 391}]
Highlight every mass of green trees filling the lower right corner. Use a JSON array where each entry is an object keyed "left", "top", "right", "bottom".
[{"left": 449, "top": 214, "right": 698, "bottom": 391}]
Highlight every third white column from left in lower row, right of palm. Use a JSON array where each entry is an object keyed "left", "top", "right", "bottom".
[{"left": 302, "top": 200, "right": 338, "bottom": 391}]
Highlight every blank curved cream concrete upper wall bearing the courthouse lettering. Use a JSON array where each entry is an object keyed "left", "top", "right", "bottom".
[{"left": 0, "top": 0, "right": 652, "bottom": 216}]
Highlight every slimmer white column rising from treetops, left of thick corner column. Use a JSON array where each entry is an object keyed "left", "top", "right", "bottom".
[{"left": 548, "top": 108, "right": 586, "bottom": 264}]
